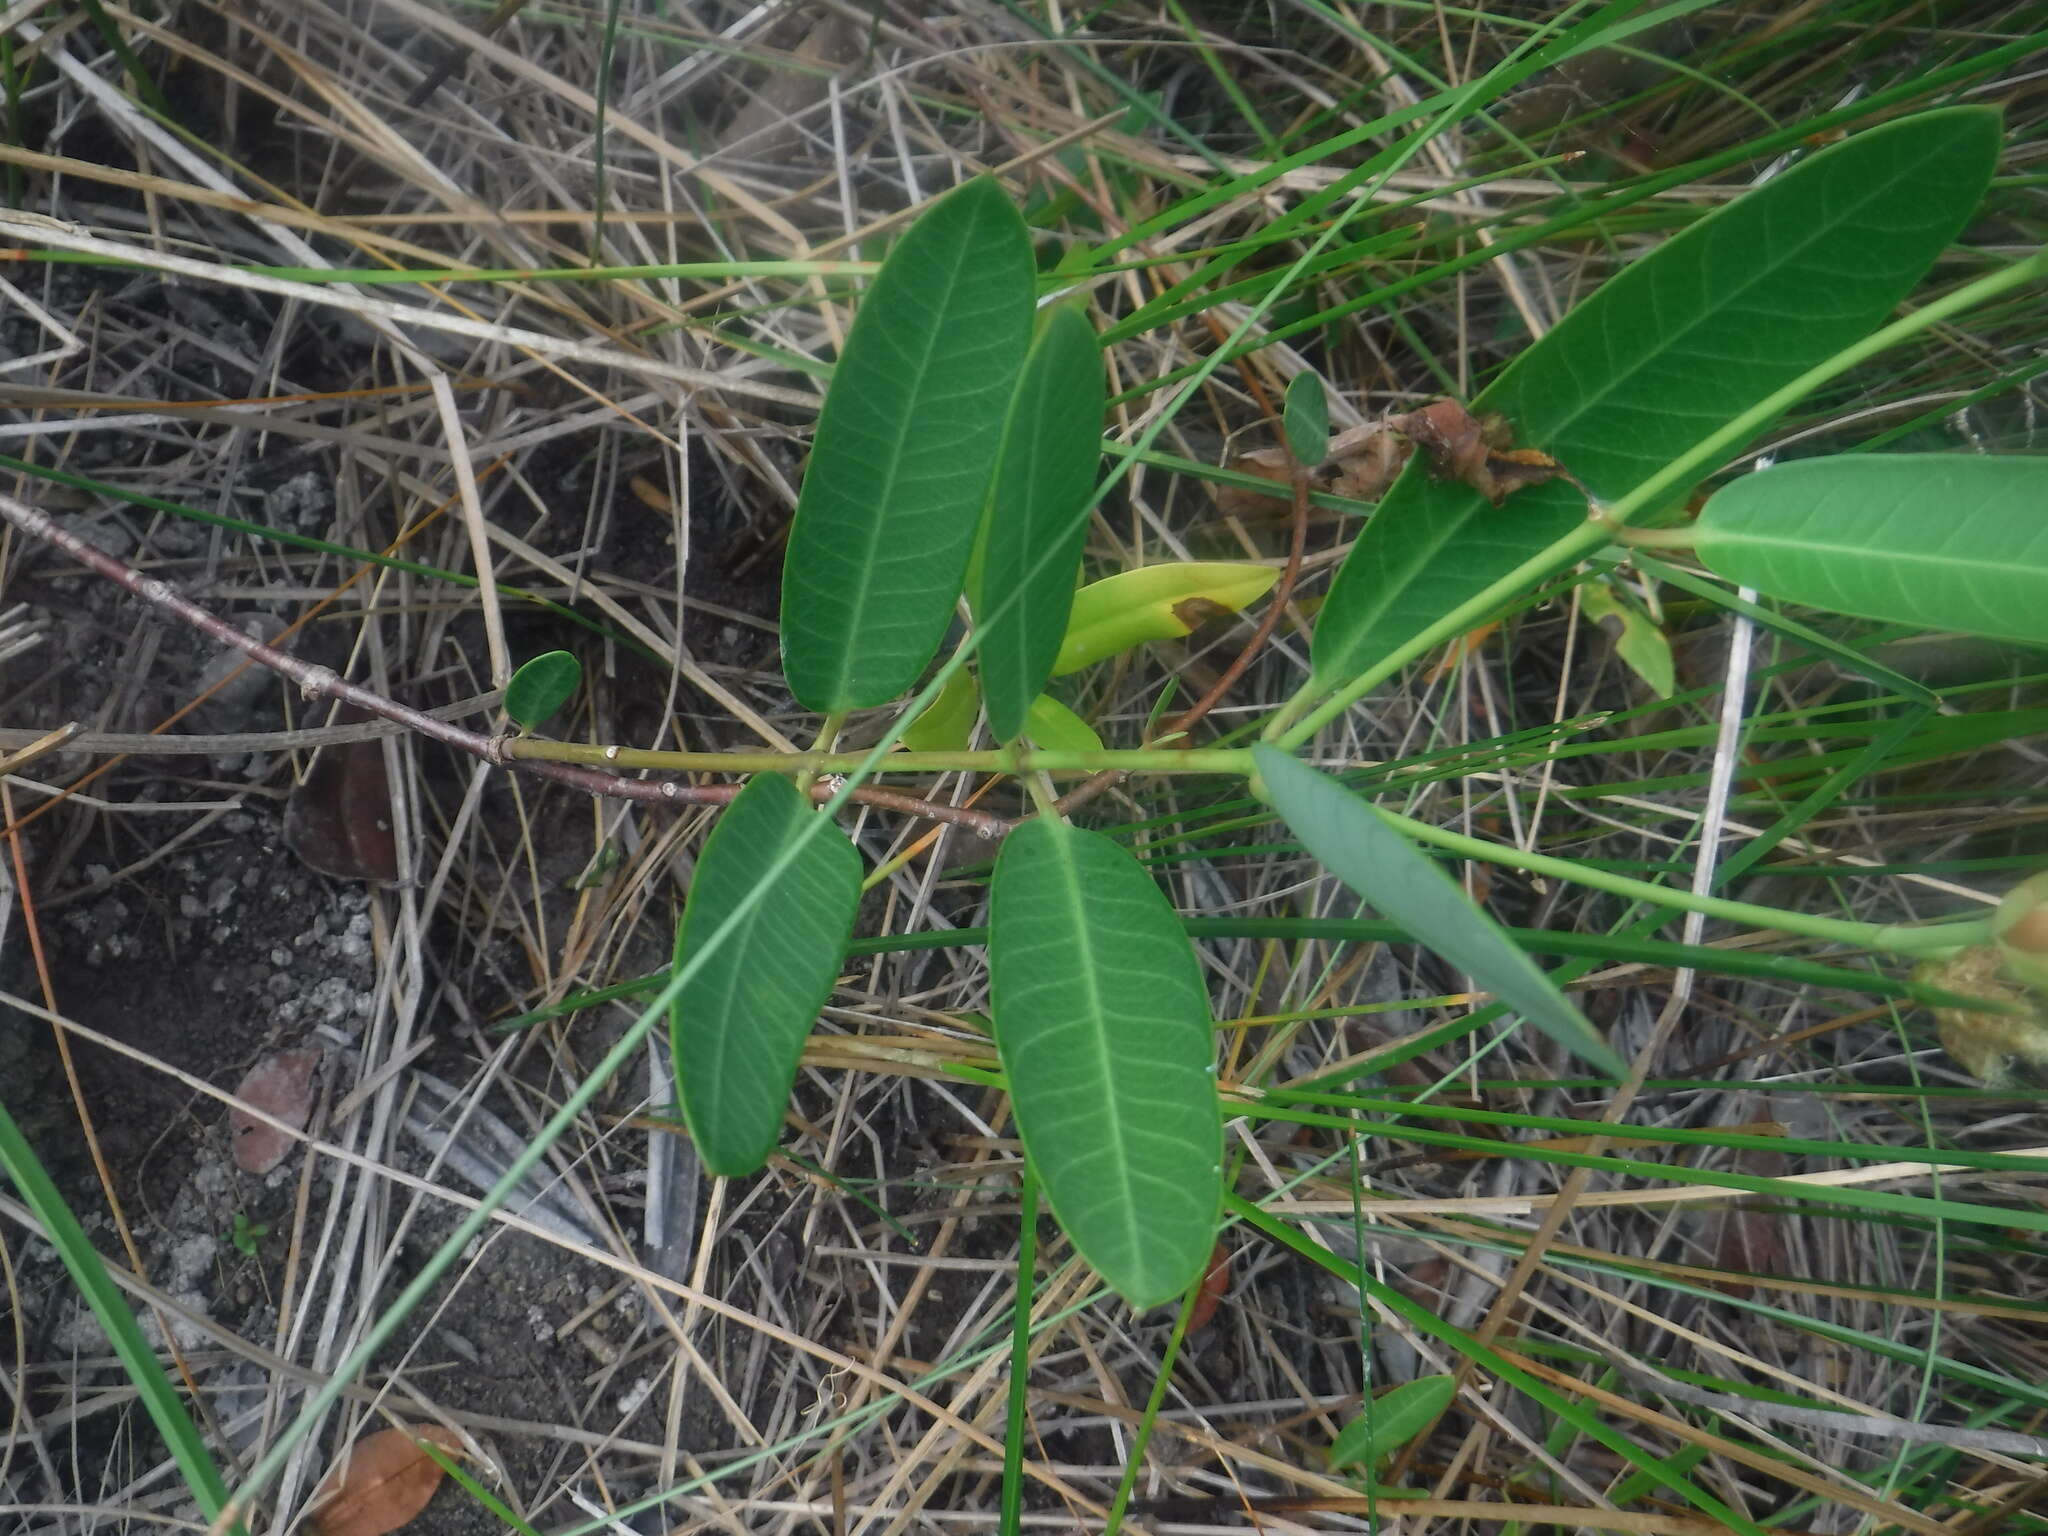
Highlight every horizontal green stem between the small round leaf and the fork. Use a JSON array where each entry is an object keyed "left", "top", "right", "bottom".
[{"left": 504, "top": 737, "right": 1251, "bottom": 776}]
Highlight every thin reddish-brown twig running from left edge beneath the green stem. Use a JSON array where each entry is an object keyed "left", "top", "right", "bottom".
[{"left": 0, "top": 496, "right": 1012, "bottom": 840}]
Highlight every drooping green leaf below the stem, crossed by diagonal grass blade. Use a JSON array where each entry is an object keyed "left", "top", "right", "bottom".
[{"left": 670, "top": 774, "right": 860, "bottom": 1178}]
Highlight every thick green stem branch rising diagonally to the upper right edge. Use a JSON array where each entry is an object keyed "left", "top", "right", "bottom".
[{"left": 1266, "top": 252, "right": 2048, "bottom": 753}]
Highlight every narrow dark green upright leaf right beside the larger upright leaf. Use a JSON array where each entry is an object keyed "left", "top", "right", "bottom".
[{"left": 969, "top": 305, "right": 1108, "bottom": 741}]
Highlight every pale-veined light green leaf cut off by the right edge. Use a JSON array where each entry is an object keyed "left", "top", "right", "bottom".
[{"left": 1692, "top": 453, "right": 2048, "bottom": 645}]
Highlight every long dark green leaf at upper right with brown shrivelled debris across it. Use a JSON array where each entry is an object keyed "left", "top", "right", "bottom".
[{"left": 1313, "top": 106, "right": 1999, "bottom": 686}]
